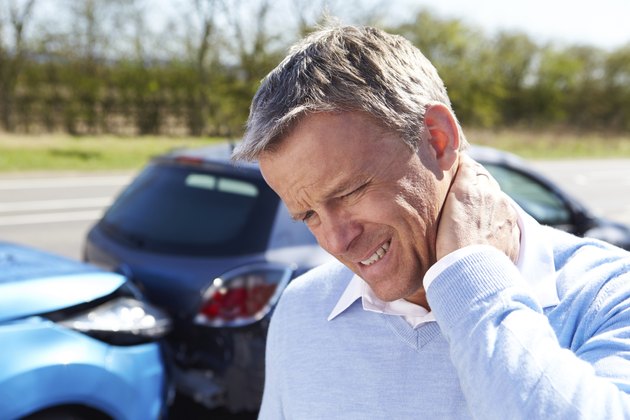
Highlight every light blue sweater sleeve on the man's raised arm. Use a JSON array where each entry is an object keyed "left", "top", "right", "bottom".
[{"left": 427, "top": 247, "right": 630, "bottom": 420}]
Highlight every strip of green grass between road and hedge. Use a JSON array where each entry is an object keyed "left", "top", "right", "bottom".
[{"left": 0, "top": 130, "right": 630, "bottom": 173}]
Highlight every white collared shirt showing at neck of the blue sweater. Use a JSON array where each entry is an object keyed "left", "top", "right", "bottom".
[{"left": 328, "top": 205, "right": 559, "bottom": 328}]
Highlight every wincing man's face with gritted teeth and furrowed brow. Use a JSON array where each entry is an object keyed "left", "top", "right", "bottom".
[{"left": 259, "top": 113, "right": 450, "bottom": 304}]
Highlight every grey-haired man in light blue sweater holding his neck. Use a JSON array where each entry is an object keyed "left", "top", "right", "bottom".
[{"left": 234, "top": 27, "right": 630, "bottom": 420}]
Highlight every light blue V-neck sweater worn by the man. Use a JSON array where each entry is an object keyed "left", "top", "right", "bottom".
[{"left": 260, "top": 229, "right": 630, "bottom": 420}]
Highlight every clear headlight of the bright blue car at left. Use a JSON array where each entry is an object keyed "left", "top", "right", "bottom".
[{"left": 56, "top": 296, "right": 171, "bottom": 345}]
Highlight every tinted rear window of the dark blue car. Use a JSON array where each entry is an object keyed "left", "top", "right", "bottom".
[{"left": 101, "top": 163, "right": 279, "bottom": 256}]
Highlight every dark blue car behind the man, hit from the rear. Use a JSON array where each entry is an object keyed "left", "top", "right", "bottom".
[{"left": 85, "top": 144, "right": 630, "bottom": 412}]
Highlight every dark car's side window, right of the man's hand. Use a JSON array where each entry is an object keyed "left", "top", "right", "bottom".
[{"left": 484, "top": 164, "right": 571, "bottom": 226}]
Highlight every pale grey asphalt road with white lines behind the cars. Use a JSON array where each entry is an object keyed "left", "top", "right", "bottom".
[{"left": 0, "top": 159, "right": 630, "bottom": 259}]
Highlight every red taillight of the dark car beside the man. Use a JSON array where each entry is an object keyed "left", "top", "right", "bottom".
[{"left": 195, "top": 263, "right": 293, "bottom": 327}]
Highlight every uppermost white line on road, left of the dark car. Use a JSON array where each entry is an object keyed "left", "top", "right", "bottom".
[{"left": 0, "top": 175, "right": 131, "bottom": 190}]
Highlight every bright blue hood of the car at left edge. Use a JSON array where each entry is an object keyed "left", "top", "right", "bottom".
[{"left": 0, "top": 242, "right": 126, "bottom": 321}]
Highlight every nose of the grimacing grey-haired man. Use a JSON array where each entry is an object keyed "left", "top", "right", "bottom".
[{"left": 315, "top": 208, "right": 362, "bottom": 256}]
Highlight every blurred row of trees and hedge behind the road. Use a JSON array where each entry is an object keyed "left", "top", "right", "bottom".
[{"left": 0, "top": 0, "right": 630, "bottom": 137}]
